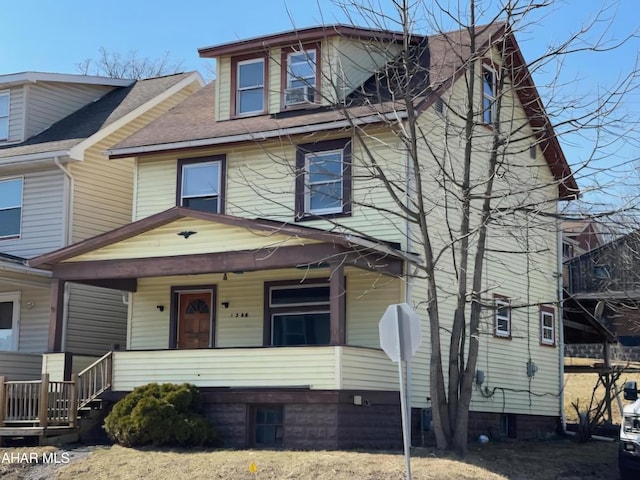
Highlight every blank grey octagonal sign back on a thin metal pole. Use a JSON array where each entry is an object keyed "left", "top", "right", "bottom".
[{"left": 378, "top": 303, "right": 422, "bottom": 480}]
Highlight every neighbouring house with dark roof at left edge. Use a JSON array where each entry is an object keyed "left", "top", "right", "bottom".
[{"left": 0, "top": 72, "right": 204, "bottom": 380}]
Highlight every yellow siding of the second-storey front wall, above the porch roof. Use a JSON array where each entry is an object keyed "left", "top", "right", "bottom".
[{"left": 136, "top": 129, "right": 406, "bottom": 244}]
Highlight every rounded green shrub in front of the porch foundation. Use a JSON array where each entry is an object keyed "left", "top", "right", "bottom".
[{"left": 104, "top": 383, "right": 221, "bottom": 447}]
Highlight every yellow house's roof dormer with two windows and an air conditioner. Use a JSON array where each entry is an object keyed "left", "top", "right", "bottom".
[{"left": 199, "top": 25, "right": 401, "bottom": 121}]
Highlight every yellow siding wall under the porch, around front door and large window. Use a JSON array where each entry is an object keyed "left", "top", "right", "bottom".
[{"left": 128, "top": 268, "right": 402, "bottom": 350}]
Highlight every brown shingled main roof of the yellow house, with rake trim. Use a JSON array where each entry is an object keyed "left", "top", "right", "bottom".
[{"left": 109, "top": 23, "right": 578, "bottom": 197}]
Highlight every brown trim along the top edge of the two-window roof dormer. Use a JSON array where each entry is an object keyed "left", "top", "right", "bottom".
[{"left": 198, "top": 24, "right": 423, "bottom": 58}]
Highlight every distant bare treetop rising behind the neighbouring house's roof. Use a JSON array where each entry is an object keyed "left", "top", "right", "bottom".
[{"left": 76, "top": 47, "right": 182, "bottom": 80}]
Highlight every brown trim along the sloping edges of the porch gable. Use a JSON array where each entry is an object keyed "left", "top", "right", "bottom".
[{"left": 28, "top": 207, "right": 401, "bottom": 269}]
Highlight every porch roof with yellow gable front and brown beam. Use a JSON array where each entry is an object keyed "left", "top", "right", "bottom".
[{"left": 29, "top": 207, "right": 419, "bottom": 291}]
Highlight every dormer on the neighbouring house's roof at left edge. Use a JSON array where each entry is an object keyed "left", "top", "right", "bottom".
[{"left": 0, "top": 72, "right": 132, "bottom": 146}]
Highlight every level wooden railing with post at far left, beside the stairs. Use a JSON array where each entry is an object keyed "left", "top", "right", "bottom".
[{"left": 0, "top": 374, "right": 78, "bottom": 428}]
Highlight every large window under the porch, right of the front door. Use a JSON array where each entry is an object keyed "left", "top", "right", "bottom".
[{"left": 267, "top": 282, "right": 330, "bottom": 346}]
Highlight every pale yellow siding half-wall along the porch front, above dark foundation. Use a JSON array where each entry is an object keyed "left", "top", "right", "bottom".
[{"left": 113, "top": 346, "right": 398, "bottom": 391}]
